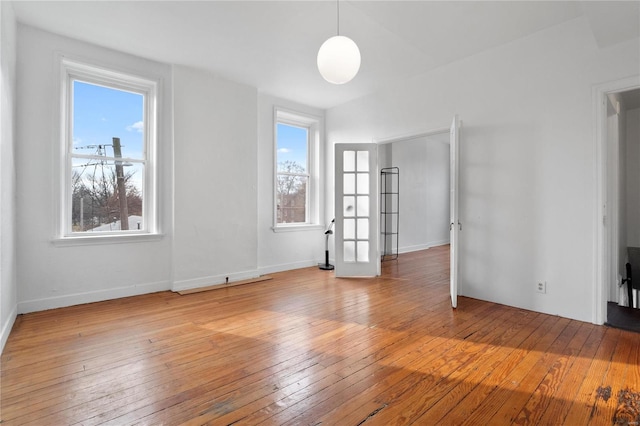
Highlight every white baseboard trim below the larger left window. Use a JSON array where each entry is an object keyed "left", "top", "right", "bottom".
[{"left": 18, "top": 281, "right": 171, "bottom": 314}]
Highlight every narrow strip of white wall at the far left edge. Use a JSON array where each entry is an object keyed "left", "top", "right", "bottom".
[{"left": 0, "top": 2, "right": 18, "bottom": 353}]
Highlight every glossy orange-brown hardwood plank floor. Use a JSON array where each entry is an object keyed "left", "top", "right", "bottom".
[{"left": 0, "top": 246, "right": 640, "bottom": 426}]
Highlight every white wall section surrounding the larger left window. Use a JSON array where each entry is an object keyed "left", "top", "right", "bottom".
[{"left": 16, "top": 25, "right": 172, "bottom": 313}]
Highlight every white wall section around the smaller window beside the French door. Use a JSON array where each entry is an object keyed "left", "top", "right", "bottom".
[{"left": 257, "top": 94, "right": 324, "bottom": 274}]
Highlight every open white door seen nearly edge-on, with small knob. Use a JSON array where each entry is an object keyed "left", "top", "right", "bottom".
[{"left": 449, "top": 115, "right": 462, "bottom": 308}]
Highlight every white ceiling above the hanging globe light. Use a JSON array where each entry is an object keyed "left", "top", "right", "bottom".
[{"left": 13, "top": 0, "right": 640, "bottom": 108}]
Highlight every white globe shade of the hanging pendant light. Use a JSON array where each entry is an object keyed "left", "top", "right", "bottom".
[{"left": 318, "top": 36, "right": 360, "bottom": 84}]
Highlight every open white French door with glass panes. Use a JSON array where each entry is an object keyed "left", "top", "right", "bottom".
[{"left": 335, "top": 143, "right": 380, "bottom": 277}]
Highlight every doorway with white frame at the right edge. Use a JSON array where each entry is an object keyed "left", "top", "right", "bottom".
[{"left": 593, "top": 77, "right": 640, "bottom": 328}]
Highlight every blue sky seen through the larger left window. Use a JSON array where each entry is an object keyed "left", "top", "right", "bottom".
[{"left": 73, "top": 81, "right": 144, "bottom": 158}]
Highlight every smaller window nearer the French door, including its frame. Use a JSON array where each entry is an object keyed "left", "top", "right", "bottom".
[{"left": 274, "top": 108, "right": 320, "bottom": 230}]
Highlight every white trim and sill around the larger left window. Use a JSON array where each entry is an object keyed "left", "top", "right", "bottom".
[{"left": 53, "top": 55, "right": 162, "bottom": 246}]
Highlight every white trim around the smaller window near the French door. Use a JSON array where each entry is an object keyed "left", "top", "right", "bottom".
[{"left": 271, "top": 106, "right": 324, "bottom": 232}]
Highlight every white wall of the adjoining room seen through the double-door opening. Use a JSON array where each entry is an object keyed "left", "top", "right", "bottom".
[{"left": 392, "top": 133, "right": 449, "bottom": 253}]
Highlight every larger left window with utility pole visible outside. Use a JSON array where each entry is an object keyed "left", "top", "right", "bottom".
[{"left": 60, "top": 59, "right": 157, "bottom": 238}]
